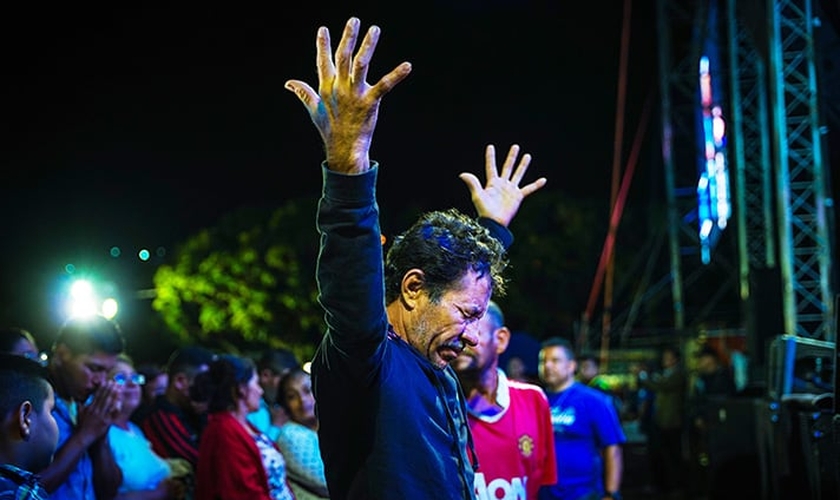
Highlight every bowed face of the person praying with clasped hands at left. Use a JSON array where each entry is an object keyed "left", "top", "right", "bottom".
[{"left": 53, "top": 344, "right": 117, "bottom": 402}]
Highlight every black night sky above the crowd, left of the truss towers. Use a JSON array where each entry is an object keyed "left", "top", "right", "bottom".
[{"left": 0, "top": 0, "right": 656, "bottom": 342}]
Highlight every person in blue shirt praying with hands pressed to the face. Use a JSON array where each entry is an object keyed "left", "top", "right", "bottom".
[{"left": 40, "top": 316, "right": 125, "bottom": 500}]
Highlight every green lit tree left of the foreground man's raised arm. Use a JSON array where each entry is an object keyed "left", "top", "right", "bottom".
[{"left": 152, "top": 199, "right": 323, "bottom": 359}]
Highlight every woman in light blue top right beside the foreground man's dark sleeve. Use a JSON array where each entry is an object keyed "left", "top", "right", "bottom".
[{"left": 277, "top": 368, "right": 329, "bottom": 500}]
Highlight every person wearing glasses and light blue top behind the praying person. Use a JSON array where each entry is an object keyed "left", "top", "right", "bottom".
[{"left": 108, "top": 354, "right": 186, "bottom": 500}]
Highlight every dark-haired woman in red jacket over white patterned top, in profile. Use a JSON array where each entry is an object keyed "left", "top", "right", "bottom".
[{"left": 195, "top": 354, "right": 295, "bottom": 500}]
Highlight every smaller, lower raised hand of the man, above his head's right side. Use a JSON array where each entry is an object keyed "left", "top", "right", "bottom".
[{"left": 458, "top": 144, "right": 547, "bottom": 227}]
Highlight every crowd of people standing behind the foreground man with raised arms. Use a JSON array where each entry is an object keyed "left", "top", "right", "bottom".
[{"left": 0, "top": 300, "right": 735, "bottom": 500}]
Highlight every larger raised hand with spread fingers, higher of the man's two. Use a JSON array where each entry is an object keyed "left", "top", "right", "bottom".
[{"left": 285, "top": 17, "right": 411, "bottom": 173}]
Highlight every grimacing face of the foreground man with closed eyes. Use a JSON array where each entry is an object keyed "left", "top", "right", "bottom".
[{"left": 405, "top": 271, "right": 492, "bottom": 369}]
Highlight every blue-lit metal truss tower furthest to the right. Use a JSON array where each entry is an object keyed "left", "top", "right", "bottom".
[{"left": 767, "top": 0, "right": 834, "bottom": 341}]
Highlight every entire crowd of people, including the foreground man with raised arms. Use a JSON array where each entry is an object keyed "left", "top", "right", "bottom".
[{"left": 0, "top": 14, "right": 740, "bottom": 500}]
